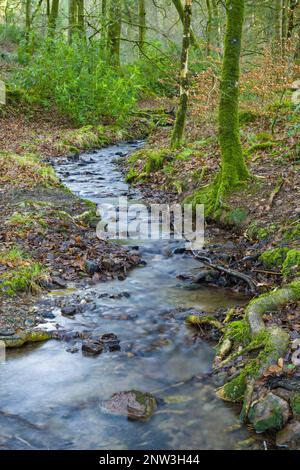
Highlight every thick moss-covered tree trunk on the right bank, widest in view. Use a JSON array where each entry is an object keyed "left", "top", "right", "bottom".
[{"left": 218, "top": 0, "right": 249, "bottom": 193}]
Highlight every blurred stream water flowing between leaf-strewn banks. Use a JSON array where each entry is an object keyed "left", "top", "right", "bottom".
[{"left": 0, "top": 143, "right": 249, "bottom": 449}]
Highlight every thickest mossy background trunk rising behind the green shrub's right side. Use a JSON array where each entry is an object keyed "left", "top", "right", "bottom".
[{"left": 107, "top": 0, "right": 122, "bottom": 66}]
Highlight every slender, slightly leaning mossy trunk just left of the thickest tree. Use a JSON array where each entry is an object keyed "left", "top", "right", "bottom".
[{"left": 171, "top": 0, "right": 193, "bottom": 148}]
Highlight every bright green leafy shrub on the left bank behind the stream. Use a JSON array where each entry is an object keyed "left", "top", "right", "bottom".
[{"left": 13, "top": 39, "right": 141, "bottom": 125}]
